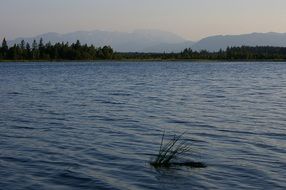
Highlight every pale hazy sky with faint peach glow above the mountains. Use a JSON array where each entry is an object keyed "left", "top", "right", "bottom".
[{"left": 0, "top": 0, "right": 286, "bottom": 40}]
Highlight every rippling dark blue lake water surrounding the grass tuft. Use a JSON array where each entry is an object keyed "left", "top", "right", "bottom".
[{"left": 0, "top": 62, "right": 286, "bottom": 190}]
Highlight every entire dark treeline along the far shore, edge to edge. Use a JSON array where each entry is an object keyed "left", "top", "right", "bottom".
[{"left": 0, "top": 38, "right": 286, "bottom": 61}]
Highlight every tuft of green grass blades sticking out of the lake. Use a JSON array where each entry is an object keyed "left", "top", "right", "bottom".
[{"left": 150, "top": 132, "right": 206, "bottom": 168}]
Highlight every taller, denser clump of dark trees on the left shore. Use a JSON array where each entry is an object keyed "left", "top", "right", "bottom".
[{"left": 0, "top": 38, "right": 114, "bottom": 60}]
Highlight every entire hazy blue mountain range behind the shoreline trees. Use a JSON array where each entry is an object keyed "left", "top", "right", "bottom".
[{"left": 8, "top": 30, "right": 286, "bottom": 53}]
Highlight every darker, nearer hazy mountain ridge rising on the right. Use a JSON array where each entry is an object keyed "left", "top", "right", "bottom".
[{"left": 192, "top": 32, "right": 286, "bottom": 51}]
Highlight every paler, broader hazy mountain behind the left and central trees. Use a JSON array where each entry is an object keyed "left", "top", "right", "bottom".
[{"left": 9, "top": 30, "right": 193, "bottom": 52}]
